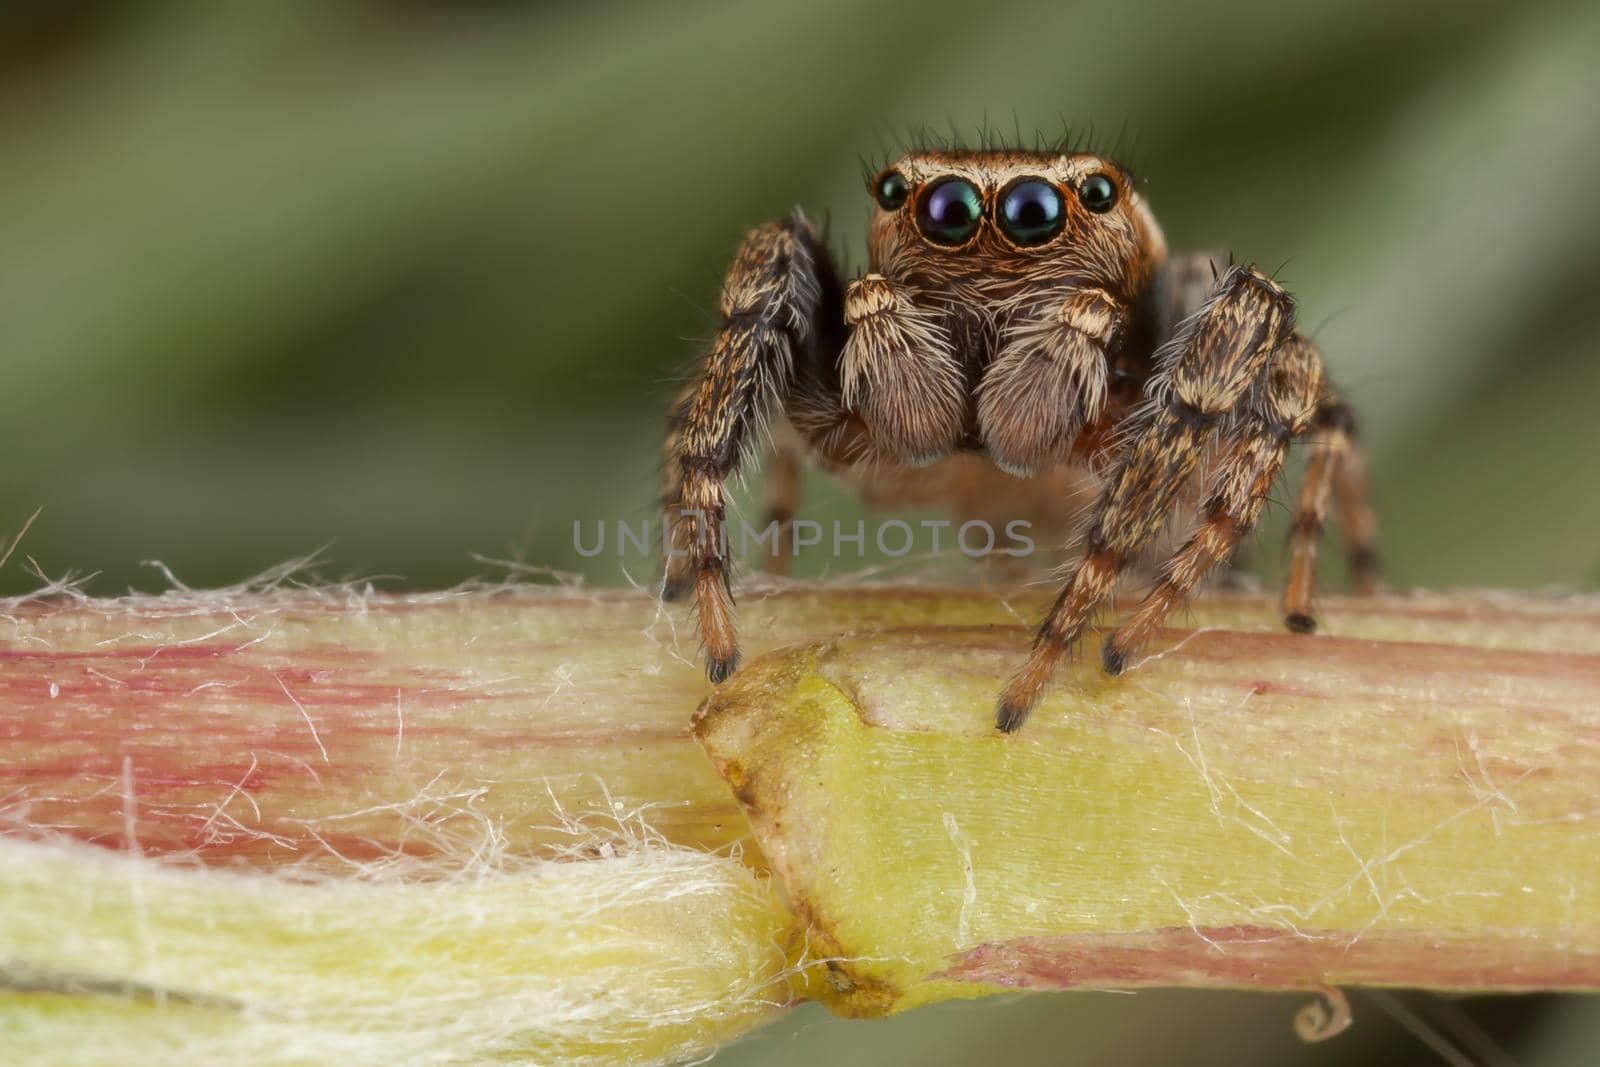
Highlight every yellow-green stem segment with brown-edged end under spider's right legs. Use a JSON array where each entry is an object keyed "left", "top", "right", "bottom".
[{"left": 698, "top": 601, "right": 1600, "bottom": 1014}]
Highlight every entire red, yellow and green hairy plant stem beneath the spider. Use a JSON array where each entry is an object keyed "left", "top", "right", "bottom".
[{"left": 0, "top": 585, "right": 1600, "bottom": 1064}]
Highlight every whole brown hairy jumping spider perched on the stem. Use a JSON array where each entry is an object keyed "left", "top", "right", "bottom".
[{"left": 662, "top": 150, "right": 1376, "bottom": 731}]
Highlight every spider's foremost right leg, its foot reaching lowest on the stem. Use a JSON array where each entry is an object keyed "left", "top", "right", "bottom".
[{"left": 995, "top": 267, "right": 1294, "bottom": 733}]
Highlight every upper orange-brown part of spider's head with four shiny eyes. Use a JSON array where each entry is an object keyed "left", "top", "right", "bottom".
[{"left": 867, "top": 150, "right": 1166, "bottom": 295}]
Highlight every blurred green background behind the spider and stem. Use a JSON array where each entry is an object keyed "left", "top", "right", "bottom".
[{"left": 0, "top": 0, "right": 1600, "bottom": 1065}]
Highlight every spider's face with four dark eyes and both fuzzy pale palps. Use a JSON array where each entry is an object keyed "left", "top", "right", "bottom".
[{"left": 840, "top": 152, "right": 1166, "bottom": 475}]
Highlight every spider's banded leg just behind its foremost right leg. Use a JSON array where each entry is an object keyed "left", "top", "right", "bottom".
[{"left": 1101, "top": 334, "right": 1326, "bottom": 675}]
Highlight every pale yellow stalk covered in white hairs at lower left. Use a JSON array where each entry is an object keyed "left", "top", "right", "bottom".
[{"left": 0, "top": 816, "right": 789, "bottom": 1065}]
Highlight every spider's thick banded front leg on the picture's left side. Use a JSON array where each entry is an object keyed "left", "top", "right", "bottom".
[{"left": 662, "top": 211, "right": 838, "bottom": 681}]
